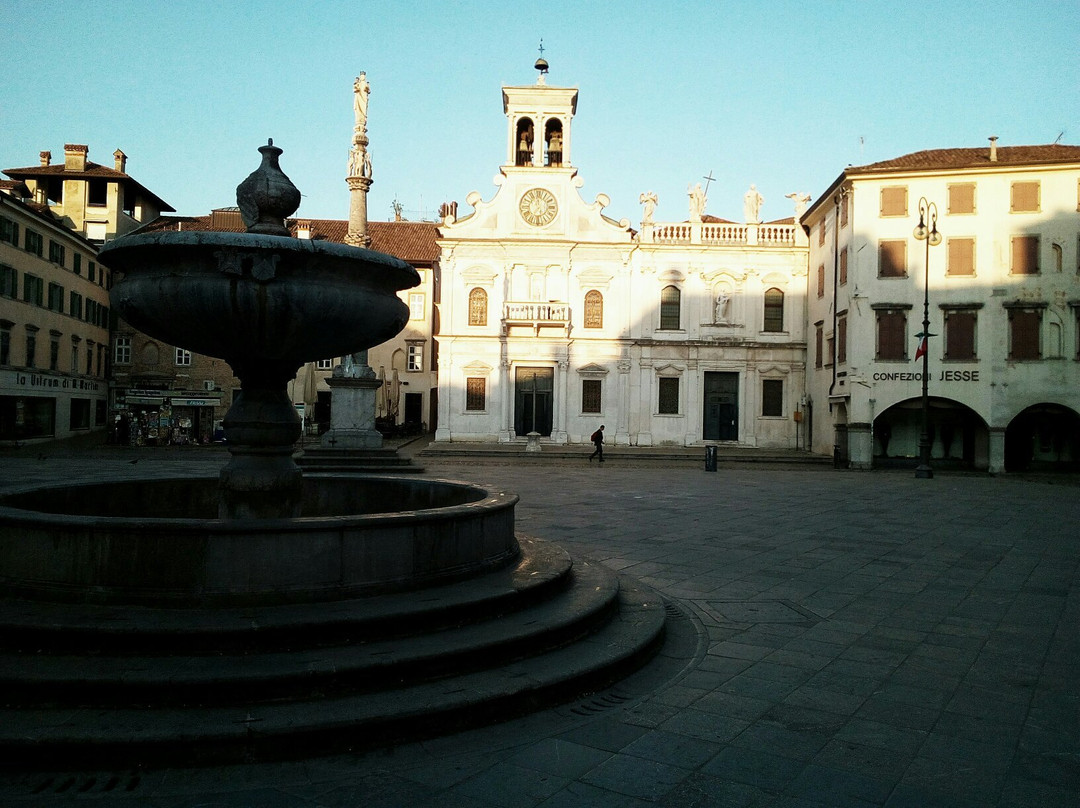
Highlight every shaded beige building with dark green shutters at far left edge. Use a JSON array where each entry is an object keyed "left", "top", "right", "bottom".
[{"left": 0, "top": 186, "right": 109, "bottom": 444}]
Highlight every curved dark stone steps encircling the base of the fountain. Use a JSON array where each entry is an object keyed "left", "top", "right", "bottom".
[{"left": 0, "top": 539, "right": 665, "bottom": 767}]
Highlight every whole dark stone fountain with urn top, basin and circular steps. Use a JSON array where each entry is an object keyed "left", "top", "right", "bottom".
[{"left": 0, "top": 142, "right": 664, "bottom": 766}]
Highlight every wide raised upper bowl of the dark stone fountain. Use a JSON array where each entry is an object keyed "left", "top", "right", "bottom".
[{"left": 99, "top": 226, "right": 420, "bottom": 380}]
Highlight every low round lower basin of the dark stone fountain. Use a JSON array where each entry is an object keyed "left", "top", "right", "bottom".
[{"left": 0, "top": 474, "right": 519, "bottom": 607}]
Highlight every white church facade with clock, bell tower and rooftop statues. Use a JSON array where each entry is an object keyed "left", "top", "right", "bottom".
[{"left": 435, "top": 72, "right": 808, "bottom": 448}]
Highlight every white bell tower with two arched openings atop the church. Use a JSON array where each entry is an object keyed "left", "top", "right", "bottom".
[{"left": 502, "top": 54, "right": 578, "bottom": 169}]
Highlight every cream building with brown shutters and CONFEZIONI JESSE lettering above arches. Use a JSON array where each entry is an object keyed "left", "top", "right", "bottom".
[{"left": 804, "top": 138, "right": 1080, "bottom": 472}]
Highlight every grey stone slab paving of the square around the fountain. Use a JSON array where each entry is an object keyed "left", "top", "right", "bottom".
[{"left": 0, "top": 449, "right": 1080, "bottom": 808}]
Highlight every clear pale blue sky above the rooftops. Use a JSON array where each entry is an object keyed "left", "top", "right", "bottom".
[{"left": 0, "top": 0, "right": 1080, "bottom": 224}]
